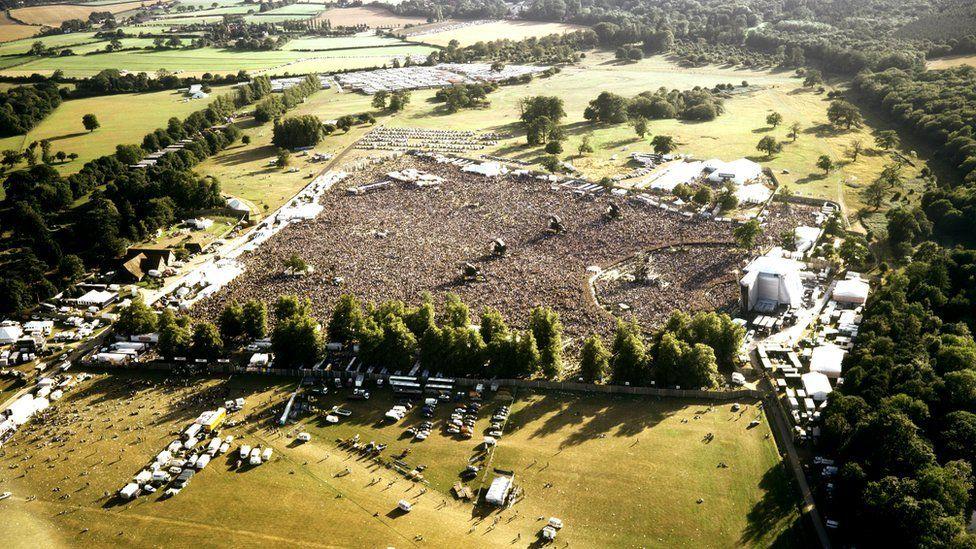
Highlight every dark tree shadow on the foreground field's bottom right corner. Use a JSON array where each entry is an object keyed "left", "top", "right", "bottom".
[{"left": 739, "top": 463, "right": 815, "bottom": 548}]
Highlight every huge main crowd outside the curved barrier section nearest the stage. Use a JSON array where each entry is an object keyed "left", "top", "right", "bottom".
[{"left": 195, "top": 156, "right": 756, "bottom": 336}]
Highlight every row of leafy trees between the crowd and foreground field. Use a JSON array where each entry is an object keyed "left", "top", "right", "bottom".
[{"left": 191, "top": 294, "right": 745, "bottom": 389}]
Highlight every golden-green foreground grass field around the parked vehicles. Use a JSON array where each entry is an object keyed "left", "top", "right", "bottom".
[{"left": 0, "top": 372, "right": 796, "bottom": 547}]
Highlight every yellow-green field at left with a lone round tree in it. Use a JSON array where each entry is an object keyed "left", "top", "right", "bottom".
[{"left": 0, "top": 88, "right": 233, "bottom": 174}]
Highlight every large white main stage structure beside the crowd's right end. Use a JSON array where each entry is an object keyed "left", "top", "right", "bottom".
[{"left": 739, "top": 255, "right": 803, "bottom": 311}]
